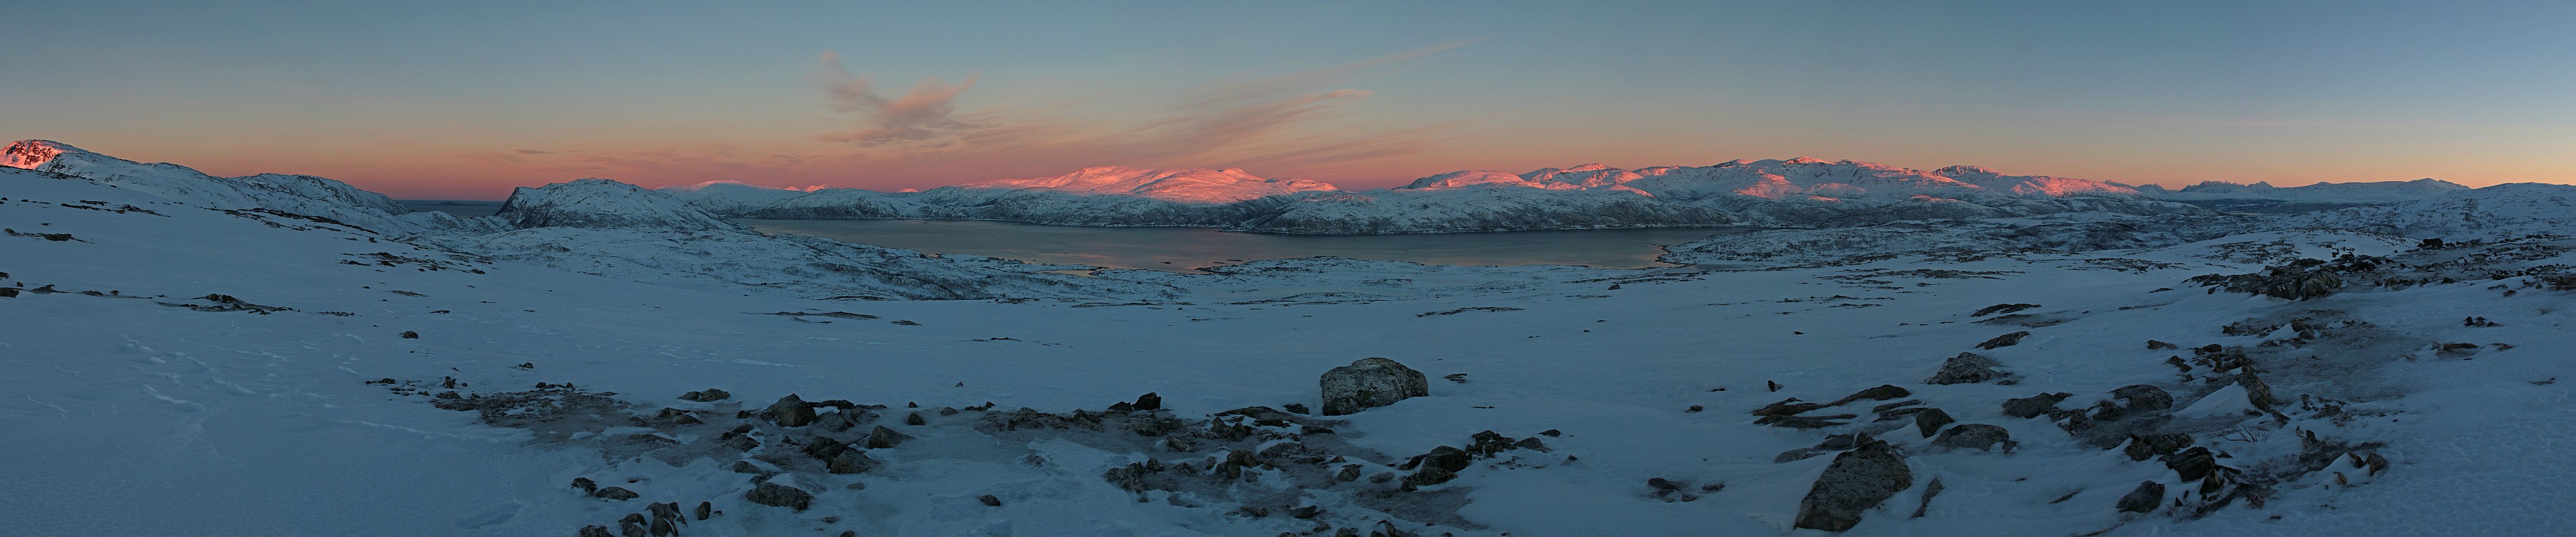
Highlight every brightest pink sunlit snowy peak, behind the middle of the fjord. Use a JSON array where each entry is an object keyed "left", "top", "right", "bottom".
[{"left": 951, "top": 165, "right": 1339, "bottom": 204}]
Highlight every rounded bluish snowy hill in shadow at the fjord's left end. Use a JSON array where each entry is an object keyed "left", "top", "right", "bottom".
[{"left": 495, "top": 178, "right": 744, "bottom": 233}]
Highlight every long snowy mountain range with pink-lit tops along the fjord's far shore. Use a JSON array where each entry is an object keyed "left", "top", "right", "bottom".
[{"left": 672, "top": 158, "right": 2200, "bottom": 235}]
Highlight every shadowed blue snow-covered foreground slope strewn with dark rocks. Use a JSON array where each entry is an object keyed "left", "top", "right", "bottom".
[{"left": 0, "top": 149, "right": 2576, "bottom": 534}]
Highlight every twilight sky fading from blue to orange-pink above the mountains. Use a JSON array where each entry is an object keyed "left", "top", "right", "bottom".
[{"left": 0, "top": 0, "right": 2576, "bottom": 199}]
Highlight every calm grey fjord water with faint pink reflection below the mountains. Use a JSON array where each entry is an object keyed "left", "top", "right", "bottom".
[{"left": 734, "top": 219, "right": 1736, "bottom": 271}]
